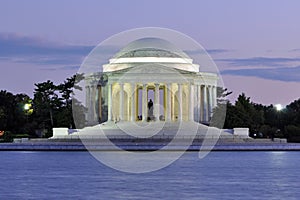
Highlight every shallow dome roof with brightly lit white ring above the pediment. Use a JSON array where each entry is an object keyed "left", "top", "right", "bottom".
[{"left": 103, "top": 38, "right": 199, "bottom": 72}]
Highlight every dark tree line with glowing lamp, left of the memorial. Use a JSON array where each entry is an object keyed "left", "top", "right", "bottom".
[{"left": 0, "top": 75, "right": 83, "bottom": 140}]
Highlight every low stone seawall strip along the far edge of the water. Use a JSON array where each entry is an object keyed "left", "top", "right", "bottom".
[{"left": 0, "top": 141, "right": 300, "bottom": 152}]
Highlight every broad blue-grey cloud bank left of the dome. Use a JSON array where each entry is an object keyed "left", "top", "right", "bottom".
[{"left": 0, "top": 33, "right": 116, "bottom": 66}]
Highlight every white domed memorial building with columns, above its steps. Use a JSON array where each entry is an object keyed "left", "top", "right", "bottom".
[{"left": 85, "top": 38, "right": 218, "bottom": 125}]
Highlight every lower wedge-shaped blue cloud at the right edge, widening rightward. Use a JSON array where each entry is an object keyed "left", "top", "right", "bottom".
[{"left": 221, "top": 66, "right": 300, "bottom": 82}]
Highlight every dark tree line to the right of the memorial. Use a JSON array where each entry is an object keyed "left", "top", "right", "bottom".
[{"left": 215, "top": 93, "right": 300, "bottom": 142}]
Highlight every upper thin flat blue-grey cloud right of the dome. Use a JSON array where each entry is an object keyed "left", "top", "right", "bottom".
[{"left": 216, "top": 57, "right": 300, "bottom": 67}]
